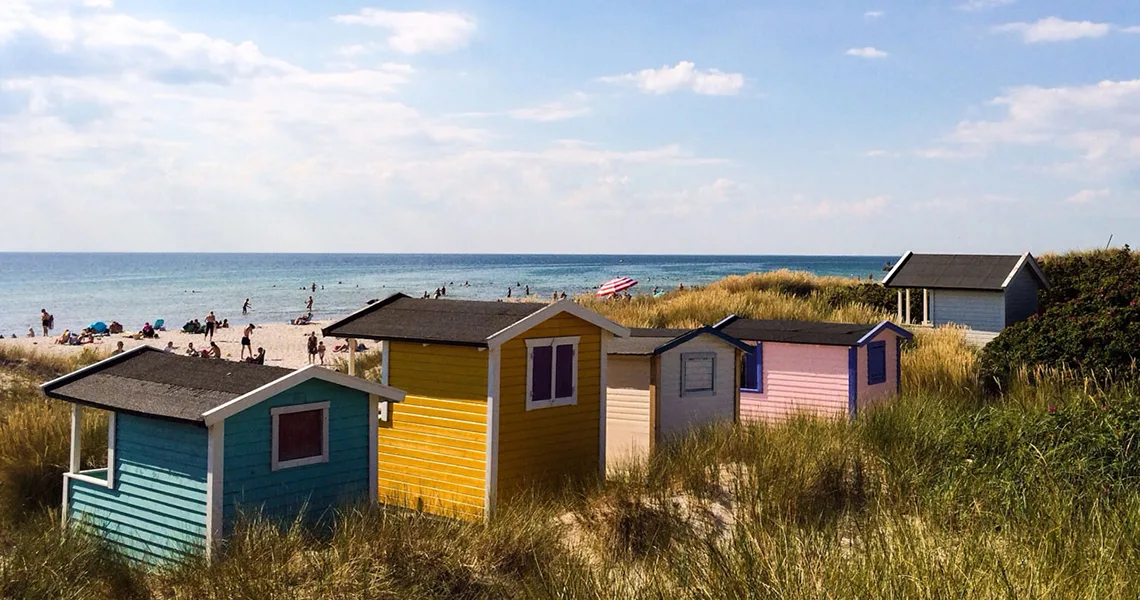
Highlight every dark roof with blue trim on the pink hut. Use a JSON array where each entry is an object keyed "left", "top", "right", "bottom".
[{"left": 714, "top": 315, "right": 911, "bottom": 346}]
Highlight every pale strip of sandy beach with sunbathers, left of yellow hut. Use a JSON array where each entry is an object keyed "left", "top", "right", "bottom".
[{"left": 0, "top": 319, "right": 360, "bottom": 368}]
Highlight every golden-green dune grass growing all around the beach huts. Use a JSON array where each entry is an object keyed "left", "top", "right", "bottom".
[{"left": 0, "top": 260, "right": 1140, "bottom": 599}]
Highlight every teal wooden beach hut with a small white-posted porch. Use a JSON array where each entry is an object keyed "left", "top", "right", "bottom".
[{"left": 42, "top": 346, "right": 404, "bottom": 563}]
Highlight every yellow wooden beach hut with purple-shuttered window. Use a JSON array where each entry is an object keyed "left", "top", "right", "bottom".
[{"left": 323, "top": 293, "right": 628, "bottom": 519}]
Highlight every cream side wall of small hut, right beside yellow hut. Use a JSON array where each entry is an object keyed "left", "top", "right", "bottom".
[{"left": 605, "top": 355, "right": 652, "bottom": 467}]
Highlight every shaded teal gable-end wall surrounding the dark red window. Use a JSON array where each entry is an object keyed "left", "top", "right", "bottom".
[{"left": 222, "top": 380, "right": 369, "bottom": 533}]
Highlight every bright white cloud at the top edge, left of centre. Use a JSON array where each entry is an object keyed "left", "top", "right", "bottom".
[{"left": 333, "top": 8, "right": 475, "bottom": 54}]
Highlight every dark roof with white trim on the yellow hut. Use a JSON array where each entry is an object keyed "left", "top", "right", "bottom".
[{"left": 321, "top": 293, "right": 629, "bottom": 348}]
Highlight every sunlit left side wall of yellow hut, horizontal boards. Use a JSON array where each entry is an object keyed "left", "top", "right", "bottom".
[{"left": 378, "top": 342, "right": 489, "bottom": 519}]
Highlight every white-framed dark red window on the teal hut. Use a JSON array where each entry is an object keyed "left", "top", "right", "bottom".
[{"left": 270, "top": 402, "right": 328, "bottom": 471}]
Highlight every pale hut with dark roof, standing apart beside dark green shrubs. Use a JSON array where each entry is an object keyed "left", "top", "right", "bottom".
[{"left": 882, "top": 252, "right": 1049, "bottom": 342}]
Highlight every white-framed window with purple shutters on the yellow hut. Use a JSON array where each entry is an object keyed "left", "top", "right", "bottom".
[{"left": 527, "top": 337, "right": 579, "bottom": 411}]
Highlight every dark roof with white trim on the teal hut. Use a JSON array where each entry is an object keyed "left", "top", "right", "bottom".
[{"left": 40, "top": 346, "right": 404, "bottom": 424}]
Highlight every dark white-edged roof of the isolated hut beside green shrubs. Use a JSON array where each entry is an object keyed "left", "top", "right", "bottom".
[{"left": 882, "top": 252, "right": 1049, "bottom": 292}]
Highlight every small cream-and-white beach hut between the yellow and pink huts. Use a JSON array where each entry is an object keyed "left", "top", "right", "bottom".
[{"left": 605, "top": 327, "right": 752, "bottom": 467}]
